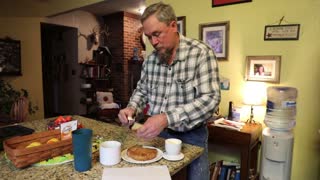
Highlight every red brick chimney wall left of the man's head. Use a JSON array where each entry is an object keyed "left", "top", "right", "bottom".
[{"left": 104, "top": 12, "right": 142, "bottom": 106}]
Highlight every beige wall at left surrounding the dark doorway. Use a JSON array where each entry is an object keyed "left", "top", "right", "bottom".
[{"left": 0, "top": 11, "right": 99, "bottom": 119}]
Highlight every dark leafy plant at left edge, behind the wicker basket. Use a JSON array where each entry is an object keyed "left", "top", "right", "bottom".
[{"left": 0, "top": 80, "right": 38, "bottom": 122}]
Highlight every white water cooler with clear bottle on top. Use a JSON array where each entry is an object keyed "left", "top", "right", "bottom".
[{"left": 260, "top": 86, "right": 297, "bottom": 180}]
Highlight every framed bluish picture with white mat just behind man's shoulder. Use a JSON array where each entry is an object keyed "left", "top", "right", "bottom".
[{"left": 199, "top": 21, "right": 229, "bottom": 60}]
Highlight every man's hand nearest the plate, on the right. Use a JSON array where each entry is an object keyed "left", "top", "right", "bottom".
[{"left": 137, "top": 114, "right": 168, "bottom": 139}]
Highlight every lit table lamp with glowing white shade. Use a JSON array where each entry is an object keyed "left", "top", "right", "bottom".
[{"left": 243, "top": 83, "right": 266, "bottom": 123}]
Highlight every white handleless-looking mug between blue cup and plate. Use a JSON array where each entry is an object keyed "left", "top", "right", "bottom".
[{"left": 99, "top": 141, "right": 121, "bottom": 166}]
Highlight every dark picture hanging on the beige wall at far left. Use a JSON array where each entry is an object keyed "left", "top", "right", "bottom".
[{"left": 0, "top": 39, "right": 22, "bottom": 76}]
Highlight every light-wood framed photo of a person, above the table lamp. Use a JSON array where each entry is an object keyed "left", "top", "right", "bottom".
[{"left": 246, "top": 56, "right": 281, "bottom": 83}]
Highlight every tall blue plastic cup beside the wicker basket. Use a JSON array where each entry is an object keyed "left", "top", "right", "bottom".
[{"left": 72, "top": 128, "right": 92, "bottom": 172}]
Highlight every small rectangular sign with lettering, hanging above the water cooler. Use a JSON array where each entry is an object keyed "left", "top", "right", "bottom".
[{"left": 264, "top": 24, "right": 300, "bottom": 41}]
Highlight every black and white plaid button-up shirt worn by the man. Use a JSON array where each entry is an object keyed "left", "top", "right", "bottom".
[{"left": 128, "top": 35, "right": 220, "bottom": 132}]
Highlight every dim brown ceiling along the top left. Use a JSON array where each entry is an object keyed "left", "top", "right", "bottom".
[{"left": 0, "top": 0, "right": 146, "bottom": 17}]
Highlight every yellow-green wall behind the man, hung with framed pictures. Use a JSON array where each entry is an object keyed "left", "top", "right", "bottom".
[{"left": 147, "top": 0, "right": 320, "bottom": 180}]
